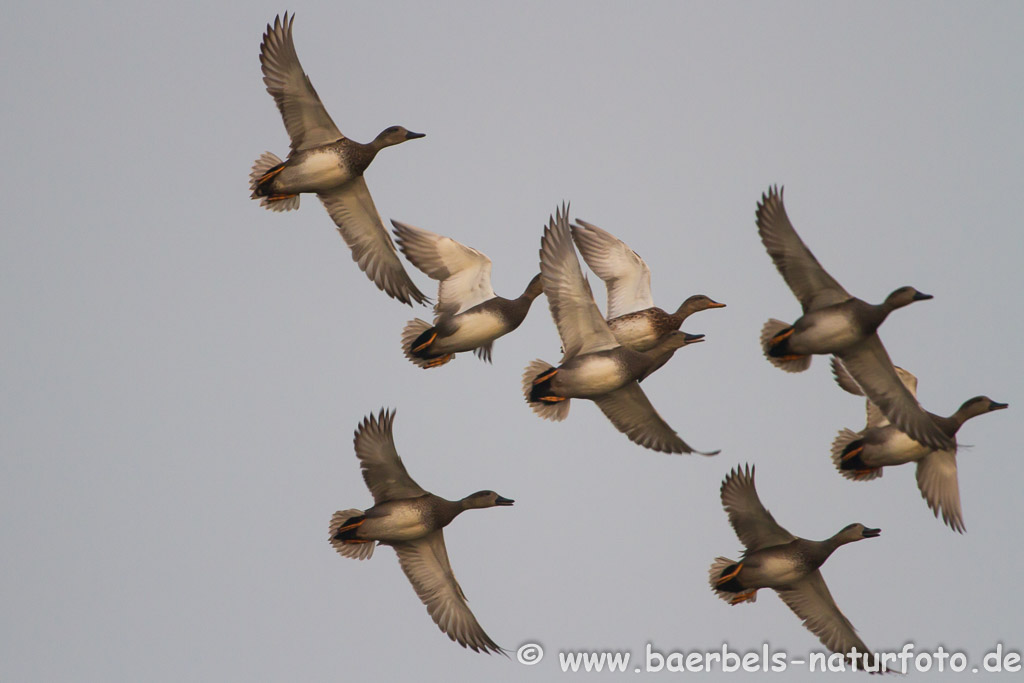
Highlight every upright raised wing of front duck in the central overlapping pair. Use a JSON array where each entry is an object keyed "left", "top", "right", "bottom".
[{"left": 541, "top": 206, "right": 618, "bottom": 362}]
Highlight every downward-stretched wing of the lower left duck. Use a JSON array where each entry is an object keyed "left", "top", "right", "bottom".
[{"left": 391, "top": 529, "right": 502, "bottom": 653}]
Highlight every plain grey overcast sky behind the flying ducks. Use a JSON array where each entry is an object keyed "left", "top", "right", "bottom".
[{"left": 0, "top": 1, "right": 1024, "bottom": 681}]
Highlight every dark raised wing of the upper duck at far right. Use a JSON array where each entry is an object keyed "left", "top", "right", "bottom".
[{"left": 757, "top": 187, "right": 853, "bottom": 313}]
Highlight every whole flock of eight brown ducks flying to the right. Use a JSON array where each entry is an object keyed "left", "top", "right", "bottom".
[{"left": 250, "top": 12, "right": 1007, "bottom": 656}]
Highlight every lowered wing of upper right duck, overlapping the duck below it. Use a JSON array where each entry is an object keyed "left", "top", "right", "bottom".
[{"left": 836, "top": 334, "right": 956, "bottom": 452}]
